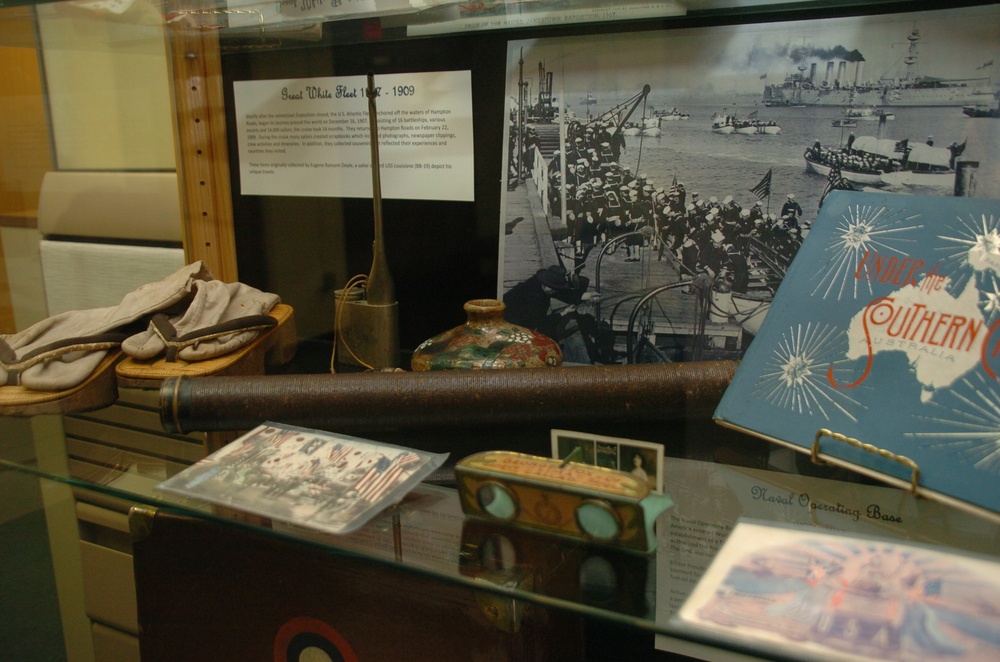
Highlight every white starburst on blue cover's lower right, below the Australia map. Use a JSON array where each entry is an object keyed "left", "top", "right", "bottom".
[{"left": 906, "top": 371, "right": 1000, "bottom": 475}]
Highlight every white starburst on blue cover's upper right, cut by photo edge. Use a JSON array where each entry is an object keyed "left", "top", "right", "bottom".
[{"left": 938, "top": 213, "right": 1000, "bottom": 323}]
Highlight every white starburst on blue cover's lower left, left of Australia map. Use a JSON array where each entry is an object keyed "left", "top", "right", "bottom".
[{"left": 755, "top": 322, "right": 863, "bottom": 422}]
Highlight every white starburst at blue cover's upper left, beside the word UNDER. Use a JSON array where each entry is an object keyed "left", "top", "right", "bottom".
[{"left": 812, "top": 205, "right": 920, "bottom": 301}]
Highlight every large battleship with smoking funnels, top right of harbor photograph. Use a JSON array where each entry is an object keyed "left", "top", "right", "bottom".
[{"left": 762, "top": 27, "right": 996, "bottom": 108}]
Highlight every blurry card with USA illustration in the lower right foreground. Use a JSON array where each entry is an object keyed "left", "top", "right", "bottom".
[{"left": 675, "top": 520, "right": 1000, "bottom": 662}]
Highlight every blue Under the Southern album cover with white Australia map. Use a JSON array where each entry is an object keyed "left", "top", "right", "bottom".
[{"left": 715, "top": 191, "right": 1000, "bottom": 517}]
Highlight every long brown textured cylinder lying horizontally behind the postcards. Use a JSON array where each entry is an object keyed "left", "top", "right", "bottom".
[{"left": 160, "top": 361, "right": 737, "bottom": 433}]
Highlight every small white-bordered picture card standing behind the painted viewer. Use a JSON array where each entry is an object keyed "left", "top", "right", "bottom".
[{"left": 551, "top": 430, "right": 664, "bottom": 494}]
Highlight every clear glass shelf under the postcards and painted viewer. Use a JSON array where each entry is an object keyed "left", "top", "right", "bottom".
[{"left": 0, "top": 408, "right": 1000, "bottom": 650}]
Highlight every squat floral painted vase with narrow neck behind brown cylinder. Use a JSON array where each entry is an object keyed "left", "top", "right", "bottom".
[{"left": 410, "top": 299, "right": 562, "bottom": 370}]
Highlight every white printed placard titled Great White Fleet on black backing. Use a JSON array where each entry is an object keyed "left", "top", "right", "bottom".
[{"left": 233, "top": 71, "right": 475, "bottom": 202}]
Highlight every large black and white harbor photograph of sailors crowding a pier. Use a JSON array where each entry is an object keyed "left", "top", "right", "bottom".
[{"left": 497, "top": 5, "right": 1000, "bottom": 365}]
